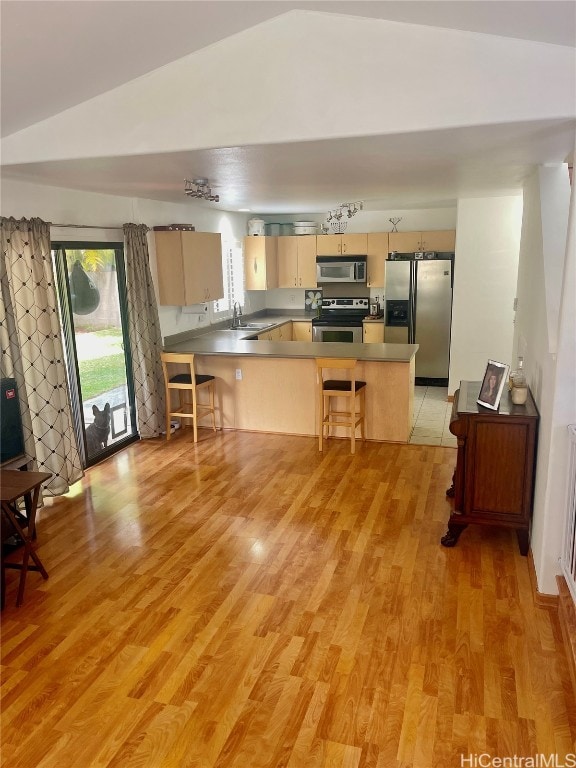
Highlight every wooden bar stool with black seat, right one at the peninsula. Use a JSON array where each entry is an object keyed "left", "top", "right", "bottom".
[{"left": 316, "top": 357, "right": 366, "bottom": 453}]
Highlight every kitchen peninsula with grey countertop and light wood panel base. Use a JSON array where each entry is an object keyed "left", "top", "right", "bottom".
[{"left": 165, "top": 318, "right": 418, "bottom": 443}]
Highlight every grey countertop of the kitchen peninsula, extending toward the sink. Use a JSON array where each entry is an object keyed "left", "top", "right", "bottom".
[{"left": 164, "top": 315, "right": 418, "bottom": 363}]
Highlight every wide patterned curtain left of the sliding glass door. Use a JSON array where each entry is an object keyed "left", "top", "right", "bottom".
[{"left": 0, "top": 217, "right": 83, "bottom": 496}]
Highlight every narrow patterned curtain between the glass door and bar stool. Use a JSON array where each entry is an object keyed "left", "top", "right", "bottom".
[{"left": 124, "top": 224, "right": 166, "bottom": 438}]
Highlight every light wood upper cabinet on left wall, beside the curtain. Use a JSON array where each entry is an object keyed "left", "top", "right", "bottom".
[{"left": 154, "top": 230, "right": 224, "bottom": 307}]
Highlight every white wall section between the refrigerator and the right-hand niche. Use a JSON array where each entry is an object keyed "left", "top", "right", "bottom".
[{"left": 448, "top": 196, "right": 522, "bottom": 394}]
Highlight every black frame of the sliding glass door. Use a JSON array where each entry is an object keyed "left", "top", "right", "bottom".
[{"left": 51, "top": 240, "right": 140, "bottom": 468}]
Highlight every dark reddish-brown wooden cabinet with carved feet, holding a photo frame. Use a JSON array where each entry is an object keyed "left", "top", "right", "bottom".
[{"left": 441, "top": 381, "right": 539, "bottom": 555}]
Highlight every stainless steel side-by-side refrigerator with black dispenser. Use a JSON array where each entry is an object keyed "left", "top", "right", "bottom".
[{"left": 384, "top": 253, "right": 453, "bottom": 385}]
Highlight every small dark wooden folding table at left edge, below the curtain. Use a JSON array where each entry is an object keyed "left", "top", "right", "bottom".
[{"left": 0, "top": 469, "right": 52, "bottom": 607}]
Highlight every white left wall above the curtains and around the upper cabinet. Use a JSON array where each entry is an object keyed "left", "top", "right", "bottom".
[{"left": 2, "top": 180, "right": 250, "bottom": 336}]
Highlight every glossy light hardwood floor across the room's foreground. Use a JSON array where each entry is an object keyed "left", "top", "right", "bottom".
[{"left": 2, "top": 430, "right": 576, "bottom": 768}]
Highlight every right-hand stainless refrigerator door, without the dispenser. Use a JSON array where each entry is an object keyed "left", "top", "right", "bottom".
[{"left": 414, "top": 261, "right": 452, "bottom": 379}]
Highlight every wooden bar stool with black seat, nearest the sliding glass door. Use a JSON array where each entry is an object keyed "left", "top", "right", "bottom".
[{"left": 161, "top": 352, "right": 216, "bottom": 443}]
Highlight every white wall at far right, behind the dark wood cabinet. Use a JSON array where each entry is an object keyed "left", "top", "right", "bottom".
[{"left": 514, "top": 164, "right": 576, "bottom": 594}]
